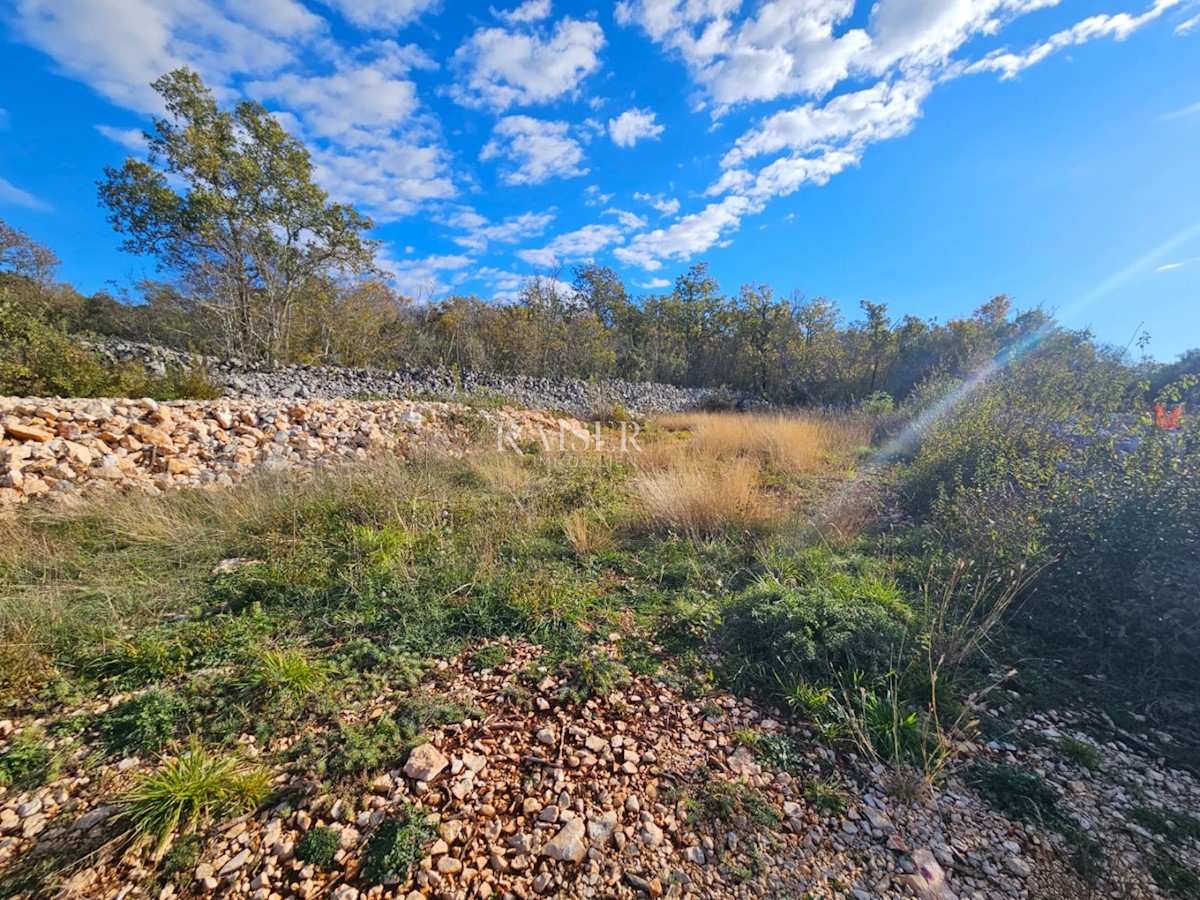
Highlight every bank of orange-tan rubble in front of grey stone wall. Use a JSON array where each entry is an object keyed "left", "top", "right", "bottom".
[{"left": 0, "top": 397, "right": 578, "bottom": 508}]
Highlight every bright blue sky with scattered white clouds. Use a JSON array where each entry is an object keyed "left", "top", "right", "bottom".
[{"left": 0, "top": 0, "right": 1200, "bottom": 358}]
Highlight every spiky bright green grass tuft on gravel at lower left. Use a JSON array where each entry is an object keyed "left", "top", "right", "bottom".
[{"left": 125, "top": 744, "right": 270, "bottom": 858}]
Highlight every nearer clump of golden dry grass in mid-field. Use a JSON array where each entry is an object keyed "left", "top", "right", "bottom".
[{"left": 634, "top": 458, "right": 763, "bottom": 540}]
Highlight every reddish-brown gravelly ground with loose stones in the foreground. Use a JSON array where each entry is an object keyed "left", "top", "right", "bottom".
[{"left": 0, "top": 635, "right": 1200, "bottom": 900}]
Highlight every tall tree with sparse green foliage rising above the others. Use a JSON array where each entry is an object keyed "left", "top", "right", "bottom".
[{"left": 100, "top": 68, "right": 377, "bottom": 360}]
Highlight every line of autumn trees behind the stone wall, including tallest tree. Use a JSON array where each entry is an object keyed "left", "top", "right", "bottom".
[{"left": 0, "top": 68, "right": 1200, "bottom": 404}]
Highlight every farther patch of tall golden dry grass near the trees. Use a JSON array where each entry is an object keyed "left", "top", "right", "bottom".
[{"left": 658, "top": 413, "right": 871, "bottom": 474}]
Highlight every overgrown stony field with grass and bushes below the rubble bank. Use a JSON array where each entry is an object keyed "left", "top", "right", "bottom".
[{"left": 0, "top": 337, "right": 1200, "bottom": 899}]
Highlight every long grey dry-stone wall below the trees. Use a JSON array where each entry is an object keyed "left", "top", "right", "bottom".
[{"left": 89, "top": 338, "right": 729, "bottom": 419}]
